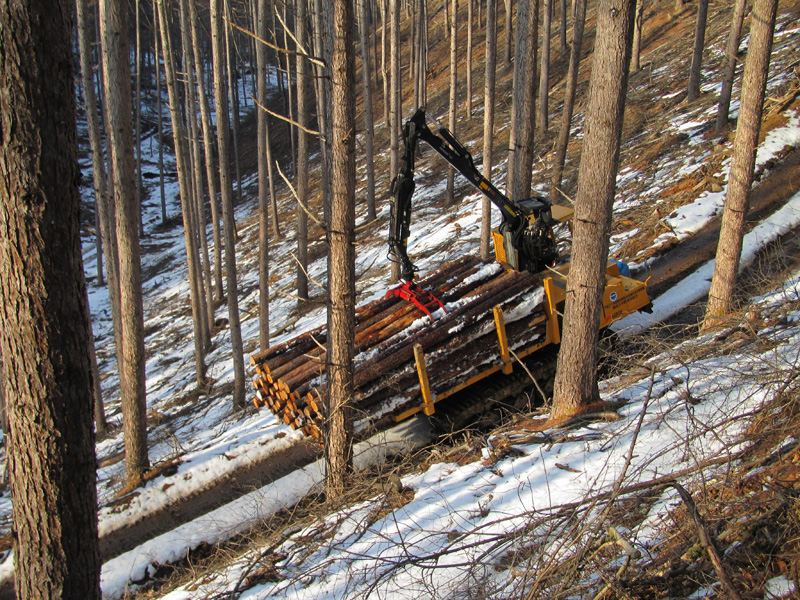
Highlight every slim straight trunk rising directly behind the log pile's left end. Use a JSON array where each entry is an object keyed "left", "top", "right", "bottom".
[{"left": 256, "top": 0, "right": 272, "bottom": 350}]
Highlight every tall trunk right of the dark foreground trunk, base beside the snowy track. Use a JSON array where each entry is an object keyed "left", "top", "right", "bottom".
[{"left": 100, "top": 0, "right": 150, "bottom": 485}]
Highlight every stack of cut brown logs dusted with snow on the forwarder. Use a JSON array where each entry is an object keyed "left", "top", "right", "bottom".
[{"left": 250, "top": 257, "right": 547, "bottom": 441}]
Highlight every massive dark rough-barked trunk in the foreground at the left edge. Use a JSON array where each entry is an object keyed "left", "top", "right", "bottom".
[{"left": 0, "top": 0, "right": 103, "bottom": 600}]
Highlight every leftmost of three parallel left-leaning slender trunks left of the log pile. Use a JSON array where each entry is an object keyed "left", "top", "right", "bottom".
[{"left": 158, "top": 0, "right": 206, "bottom": 386}]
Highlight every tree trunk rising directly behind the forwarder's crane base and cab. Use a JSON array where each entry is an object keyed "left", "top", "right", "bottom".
[{"left": 506, "top": 0, "right": 539, "bottom": 200}]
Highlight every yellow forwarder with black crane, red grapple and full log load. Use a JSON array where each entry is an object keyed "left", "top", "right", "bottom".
[{"left": 251, "top": 109, "right": 650, "bottom": 441}]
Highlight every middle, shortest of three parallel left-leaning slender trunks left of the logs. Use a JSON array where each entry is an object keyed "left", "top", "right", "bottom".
[{"left": 189, "top": 0, "right": 225, "bottom": 302}]
